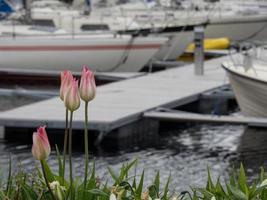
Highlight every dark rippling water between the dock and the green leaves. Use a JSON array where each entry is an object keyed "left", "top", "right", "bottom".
[{"left": 0, "top": 93, "right": 267, "bottom": 191}]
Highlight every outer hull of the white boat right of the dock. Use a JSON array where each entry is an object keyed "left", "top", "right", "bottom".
[{"left": 223, "top": 63, "right": 267, "bottom": 117}]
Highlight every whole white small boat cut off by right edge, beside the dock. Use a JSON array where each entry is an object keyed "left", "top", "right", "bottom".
[{"left": 222, "top": 54, "right": 267, "bottom": 117}]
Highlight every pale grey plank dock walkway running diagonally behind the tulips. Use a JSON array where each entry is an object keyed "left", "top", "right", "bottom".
[{"left": 0, "top": 56, "right": 234, "bottom": 132}]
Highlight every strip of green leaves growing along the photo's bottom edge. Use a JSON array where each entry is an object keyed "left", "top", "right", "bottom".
[{"left": 0, "top": 158, "right": 267, "bottom": 200}]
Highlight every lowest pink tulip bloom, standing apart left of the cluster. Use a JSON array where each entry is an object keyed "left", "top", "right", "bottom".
[{"left": 32, "top": 126, "right": 51, "bottom": 160}]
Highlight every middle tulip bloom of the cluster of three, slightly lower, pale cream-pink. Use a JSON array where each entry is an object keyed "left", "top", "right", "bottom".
[{"left": 64, "top": 79, "right": 80, "bottom": 112}]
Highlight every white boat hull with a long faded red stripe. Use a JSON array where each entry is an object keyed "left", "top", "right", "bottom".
[{"left": 0, "top": 34, "right": 167, "bottom": 72}]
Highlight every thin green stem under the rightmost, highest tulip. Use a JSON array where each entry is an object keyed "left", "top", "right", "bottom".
[{"left": 84, "top": 101, "right": 89, "bottom": 189}]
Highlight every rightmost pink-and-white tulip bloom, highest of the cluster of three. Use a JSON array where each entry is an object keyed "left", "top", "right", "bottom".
[{"left": 79, "top": 66, "right": 96, "bottom": 102}]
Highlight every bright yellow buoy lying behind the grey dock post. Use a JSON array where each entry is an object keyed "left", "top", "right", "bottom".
[{"left": 186, "top": 38, "right": 230, "bottom": 52}]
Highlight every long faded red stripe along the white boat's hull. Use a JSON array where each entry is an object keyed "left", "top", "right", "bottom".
[{"left": 0, "top": 44, "right": 162, "bottom": 51}]
